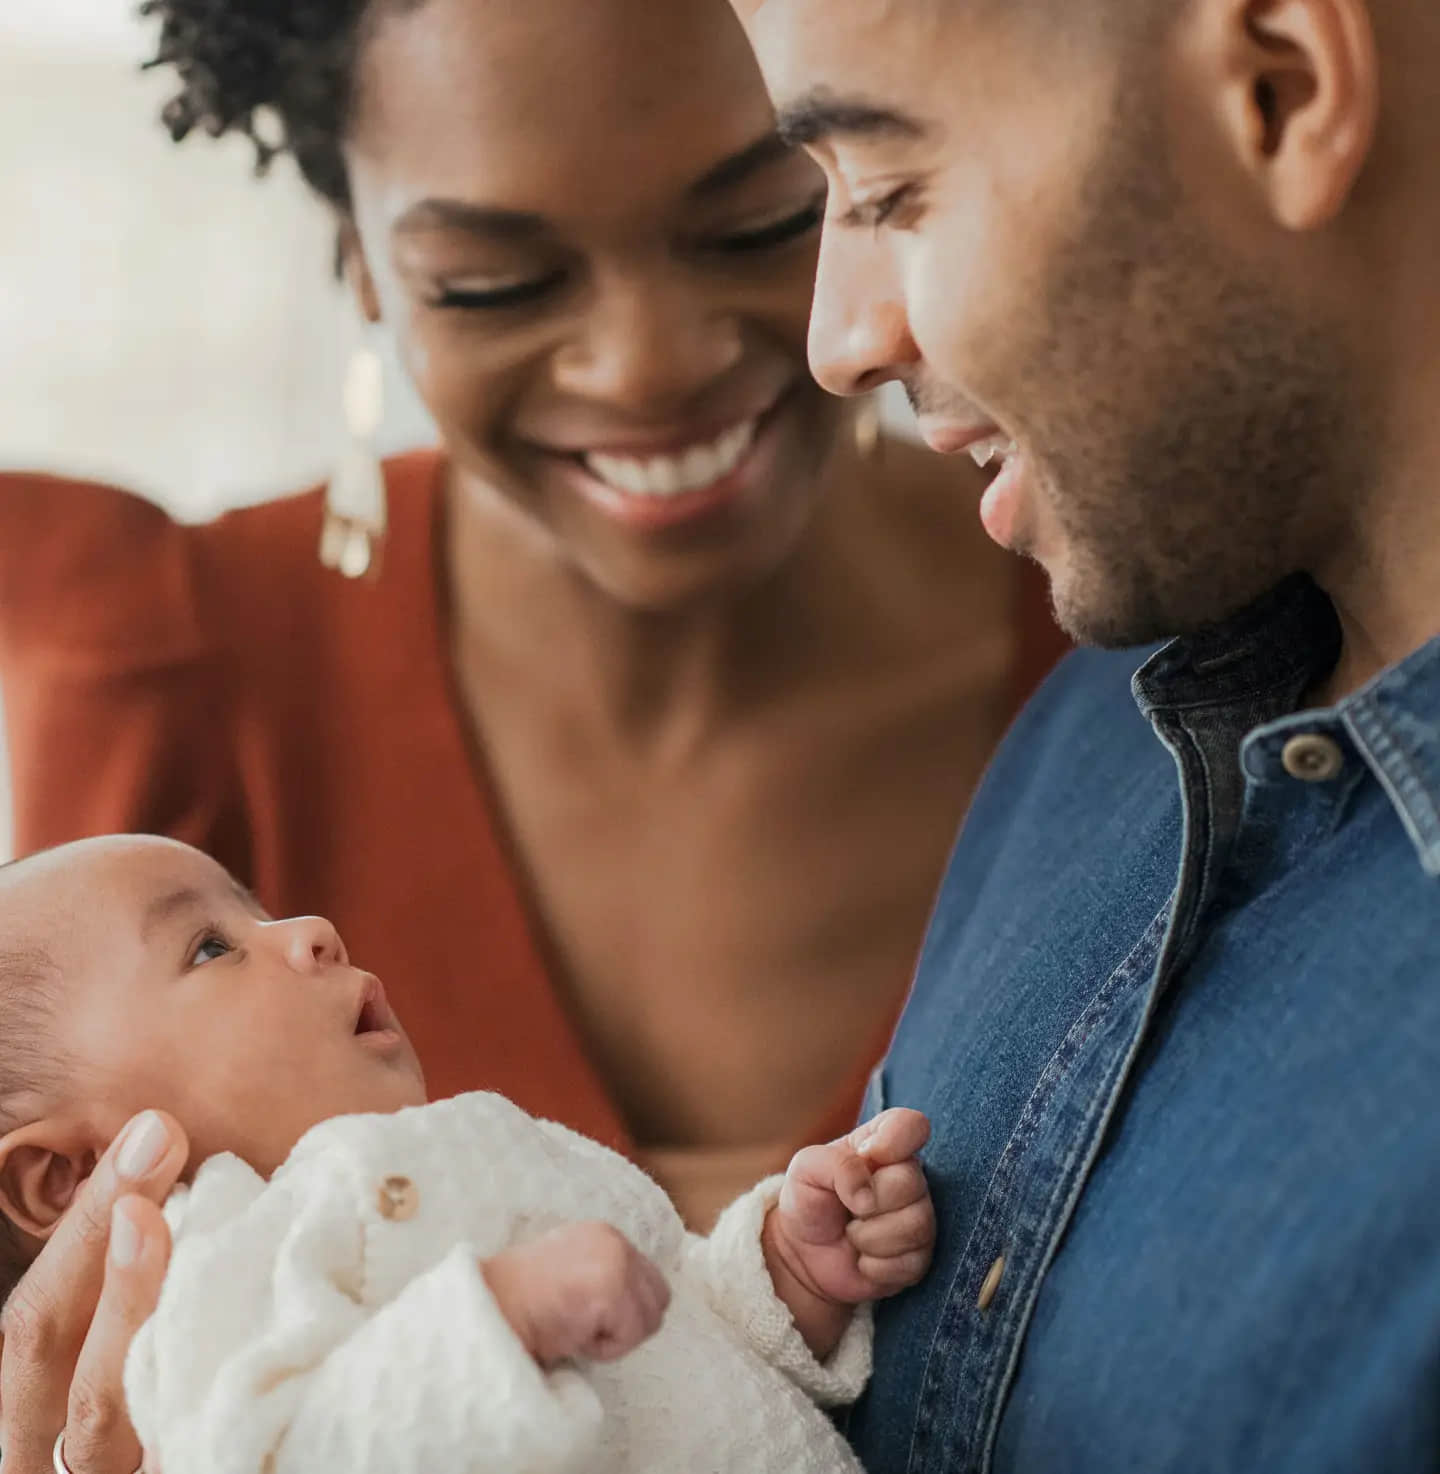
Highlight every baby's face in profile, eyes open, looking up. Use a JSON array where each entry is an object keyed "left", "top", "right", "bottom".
[{"left": 0, "top": 839, "right": 424, "bottom": 1173}]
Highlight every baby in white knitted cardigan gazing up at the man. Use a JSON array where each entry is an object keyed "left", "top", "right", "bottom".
[{"left": 0, "top": 837, "right": 934, "bottom": 1474}]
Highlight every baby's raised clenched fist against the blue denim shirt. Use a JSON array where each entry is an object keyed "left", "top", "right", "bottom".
[{"left": 765, "top": 1110, "right": 934, "bottom": 1328}]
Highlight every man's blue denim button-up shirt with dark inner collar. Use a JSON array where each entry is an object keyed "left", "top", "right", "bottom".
[{"left": 850, "top": 579, "right": 1440, "bottom": 1474}]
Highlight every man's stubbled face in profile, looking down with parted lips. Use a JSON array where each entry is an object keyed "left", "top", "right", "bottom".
[{"left": 735, "top": 0, "right": 1363, "bottom": 644}]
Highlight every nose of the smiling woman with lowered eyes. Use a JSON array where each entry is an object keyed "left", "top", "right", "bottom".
[{"left": 554, "top": 276, "right": 744, "bottom": 419}]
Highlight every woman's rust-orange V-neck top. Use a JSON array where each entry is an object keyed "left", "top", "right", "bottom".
[{"left": 0, "top": 451, "right": 1063, "bottom": 1173}]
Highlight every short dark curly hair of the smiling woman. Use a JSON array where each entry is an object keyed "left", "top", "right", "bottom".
[{"left": 140, "top": 0, "right": 423, "bottom": 211}]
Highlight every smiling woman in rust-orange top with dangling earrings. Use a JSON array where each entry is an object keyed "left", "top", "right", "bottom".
[{"left": 0, "top": 0, "right": 1052, "bottom": 1474}]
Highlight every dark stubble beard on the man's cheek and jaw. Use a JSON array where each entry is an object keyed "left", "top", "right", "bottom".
[{"left": 1017, "top": 88, "right": 1374, "bottom": 647}]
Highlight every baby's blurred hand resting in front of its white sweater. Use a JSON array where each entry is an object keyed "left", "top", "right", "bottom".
[{"left": 480, "top": 1223, "right": 671, "bottom": 1368}]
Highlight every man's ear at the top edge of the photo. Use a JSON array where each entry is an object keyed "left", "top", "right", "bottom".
[{"left": 1200, "top": 0, "right": 1380, "bottom": 230}]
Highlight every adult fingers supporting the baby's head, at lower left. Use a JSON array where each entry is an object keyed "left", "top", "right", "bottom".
[{"left": 0, "top": 1111, "right": 189, "bottom": 1474}]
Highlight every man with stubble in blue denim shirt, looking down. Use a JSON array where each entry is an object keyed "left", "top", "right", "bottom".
[{"left": 735, "top": 0, "right": 1440, "bottom": 1474}]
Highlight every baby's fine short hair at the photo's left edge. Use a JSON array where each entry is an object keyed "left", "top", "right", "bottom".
[{"left": 0, "top": 862, "right": 63, "bottom": 1306}]
